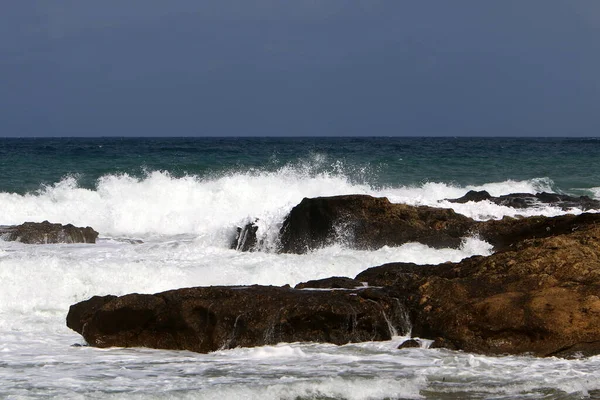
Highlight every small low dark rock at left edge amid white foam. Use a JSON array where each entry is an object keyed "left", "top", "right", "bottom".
[{"left": 0, "top": 221, "right": 98, "bottom": 244}]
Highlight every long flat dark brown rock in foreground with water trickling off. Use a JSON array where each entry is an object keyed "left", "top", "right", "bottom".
[{"left": 67, "top": 286, "right": 408, "bottom": 353}]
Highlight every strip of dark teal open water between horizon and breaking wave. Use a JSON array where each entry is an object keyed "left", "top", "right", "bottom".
[{"left": 0, "top": 138, "right": 600, "bottom": 195}]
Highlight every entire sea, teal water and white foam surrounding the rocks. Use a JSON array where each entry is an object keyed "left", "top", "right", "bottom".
[{"left": 0, "top": 137, "right": 600, "bottom": 400}]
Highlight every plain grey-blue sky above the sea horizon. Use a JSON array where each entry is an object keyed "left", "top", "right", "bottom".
[{"left": 0, "top": 0, "right": 600, "bottom": 137}]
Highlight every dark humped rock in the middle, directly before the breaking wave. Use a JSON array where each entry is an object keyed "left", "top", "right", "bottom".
[{"left": 280, "top": 195, "right": 600, "bottom": 254}]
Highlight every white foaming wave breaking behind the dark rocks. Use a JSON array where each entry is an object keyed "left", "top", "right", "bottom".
[{"left": 0, "top": 165, "right": 580, "bottom": 238}]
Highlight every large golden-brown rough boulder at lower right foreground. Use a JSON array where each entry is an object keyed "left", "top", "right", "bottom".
[{"left": 356, "top": 225, "right": 600, "bottom": 357}]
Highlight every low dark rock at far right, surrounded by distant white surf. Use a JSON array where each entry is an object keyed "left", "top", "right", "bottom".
[{"left": 448, "top": 190, "right": 600, "bottom": 211}]
